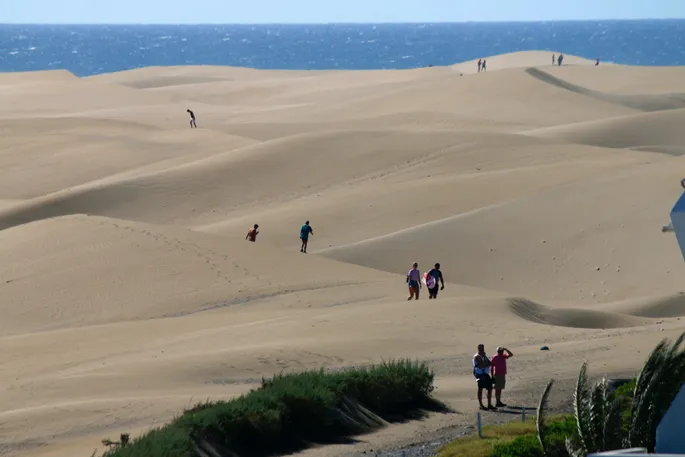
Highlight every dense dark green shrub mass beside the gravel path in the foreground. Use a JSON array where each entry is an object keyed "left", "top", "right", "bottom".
[{"left": 106, "top": 360, "right": 440, "bottom": 457}]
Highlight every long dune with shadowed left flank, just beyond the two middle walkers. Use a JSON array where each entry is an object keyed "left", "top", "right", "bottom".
[{"left": 0, "top": 130, "right": 535, "bottom": 228}]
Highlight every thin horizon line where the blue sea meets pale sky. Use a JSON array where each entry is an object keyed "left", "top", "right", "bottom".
[{"left": 0, "top": 17, "right": 685, "bottom": 26}]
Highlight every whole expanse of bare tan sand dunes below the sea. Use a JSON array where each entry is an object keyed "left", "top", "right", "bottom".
[{"left": 0, "top": 52, "right": 685, "bottom": 457}]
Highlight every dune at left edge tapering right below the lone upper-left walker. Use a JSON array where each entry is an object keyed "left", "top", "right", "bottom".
[{"left": 0, "top": 117, "right": 255, "bottom": 199}]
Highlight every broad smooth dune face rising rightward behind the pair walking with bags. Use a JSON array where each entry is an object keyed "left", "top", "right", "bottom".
[{"left": 321, "top": 156, "right": 685, "bottom": 303}]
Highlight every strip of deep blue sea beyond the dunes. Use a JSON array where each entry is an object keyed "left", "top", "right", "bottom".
[{"left": 0, "top": 20, "right": 685, "bottom": 76}]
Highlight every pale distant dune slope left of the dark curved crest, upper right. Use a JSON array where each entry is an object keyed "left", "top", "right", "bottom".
[{"left": 214, "top": 67, "right": 636, "bottom": 127}]
